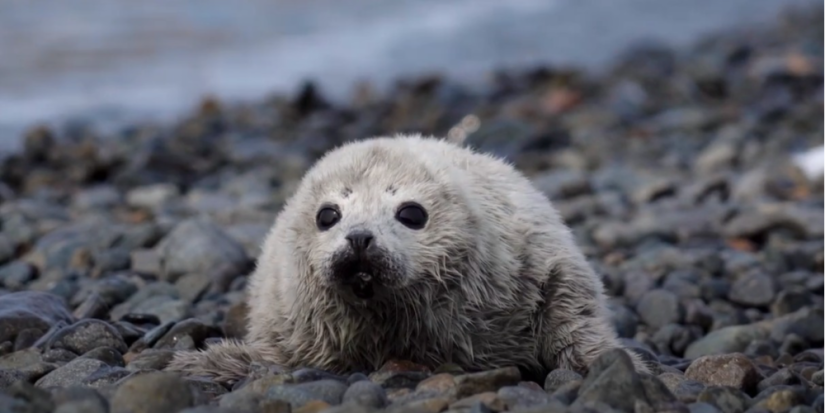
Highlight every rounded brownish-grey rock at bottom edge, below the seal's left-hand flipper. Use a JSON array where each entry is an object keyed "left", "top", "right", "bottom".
[{"left": 111, "top": 372, "right": 195, "bottom": 413}]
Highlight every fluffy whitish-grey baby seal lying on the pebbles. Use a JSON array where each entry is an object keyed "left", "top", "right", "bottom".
[{"left": 167, "top": 135, "right": 649, "bottom": 381}]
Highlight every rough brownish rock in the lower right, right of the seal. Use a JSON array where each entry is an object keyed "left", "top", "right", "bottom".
[{"left": 685, "top": 353, "right": 764, "bottom": 394}]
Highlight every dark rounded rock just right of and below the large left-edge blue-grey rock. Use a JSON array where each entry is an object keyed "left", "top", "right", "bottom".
[{"left": 47, "top": 319, "right": 126, "bottom": 354}]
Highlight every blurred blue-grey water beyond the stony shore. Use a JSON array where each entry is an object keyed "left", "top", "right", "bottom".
[{"left": 0, "top": 0, "right": 813, "bottom": 151}]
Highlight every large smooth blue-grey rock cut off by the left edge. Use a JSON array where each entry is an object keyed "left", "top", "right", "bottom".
[{"left": 0, "top": 291, "right": 74, "bottom": 343}]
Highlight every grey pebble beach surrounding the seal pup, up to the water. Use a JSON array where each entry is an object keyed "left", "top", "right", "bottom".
[{"left": 0, "top": 7, "right": 825, "bottom": 413}]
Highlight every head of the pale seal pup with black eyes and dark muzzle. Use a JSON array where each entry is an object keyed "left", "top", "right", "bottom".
[{"left": 286, "top": 138, "right": 474, "bottom": 303}]
